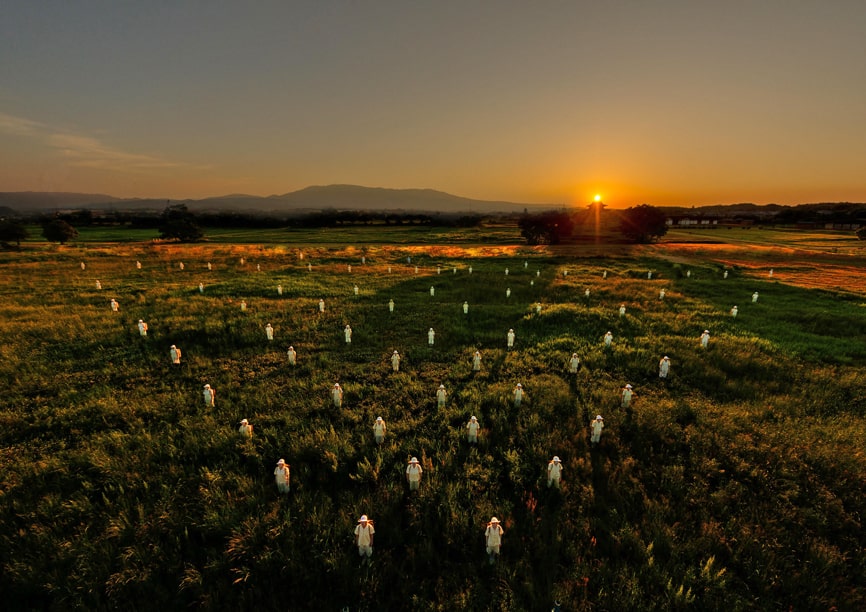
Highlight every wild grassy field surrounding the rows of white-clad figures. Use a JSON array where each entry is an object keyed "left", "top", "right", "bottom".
[{"left": 0, "top": 230, "right": 866, "bottom": 611}]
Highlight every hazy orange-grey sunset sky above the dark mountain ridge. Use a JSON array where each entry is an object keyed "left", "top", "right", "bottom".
[{"left": 0, "top": 0, "right": 866, "bottom": 208}]
